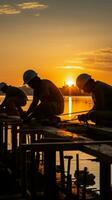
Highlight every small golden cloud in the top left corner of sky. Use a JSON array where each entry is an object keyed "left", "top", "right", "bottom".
[{"left": 0, "top": 1, "right": 48, "bottom": 16}]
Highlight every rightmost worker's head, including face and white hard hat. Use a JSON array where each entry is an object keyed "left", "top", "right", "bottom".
[{"left": 76, "top": 74, "right": 95, "bottom": 93}]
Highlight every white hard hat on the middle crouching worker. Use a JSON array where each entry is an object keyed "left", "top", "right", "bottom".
[{"left": 23, "top": 69, "right": 37, "bottom": 84}]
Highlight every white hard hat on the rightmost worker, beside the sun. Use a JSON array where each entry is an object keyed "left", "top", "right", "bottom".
[{"left": 76, "top": 74, "right": 91, "bottom": 89}]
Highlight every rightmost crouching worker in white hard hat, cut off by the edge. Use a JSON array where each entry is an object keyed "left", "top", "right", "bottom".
[{"left": 76, "top": 74, "right": 112, "bottom": 126}]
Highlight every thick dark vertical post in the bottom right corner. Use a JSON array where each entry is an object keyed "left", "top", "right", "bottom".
[{"left": 100, "top": 161, "right": 112, "bottom": 200}]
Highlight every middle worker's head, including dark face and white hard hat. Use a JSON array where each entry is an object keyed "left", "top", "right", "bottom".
[{"left": 23, "top": 69, "right": 40, "bottom": 88}]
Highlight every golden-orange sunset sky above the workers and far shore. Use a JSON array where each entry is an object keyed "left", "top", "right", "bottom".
[{"left": 0, "top": 0, "right": 112, "bottom": 87}]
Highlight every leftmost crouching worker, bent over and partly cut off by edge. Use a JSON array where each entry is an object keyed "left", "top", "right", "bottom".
[{"left": 0, "top": 82, "right": 27, "bottom": 118}]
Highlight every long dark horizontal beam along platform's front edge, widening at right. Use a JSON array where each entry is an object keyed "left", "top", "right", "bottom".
[{"left": 21, "top": 141, "right": 112, "bottom": 163}]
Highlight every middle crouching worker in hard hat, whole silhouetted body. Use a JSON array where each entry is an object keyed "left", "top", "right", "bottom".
[{"left": 23, "top": 69, "right": 64, "bottom": 122}]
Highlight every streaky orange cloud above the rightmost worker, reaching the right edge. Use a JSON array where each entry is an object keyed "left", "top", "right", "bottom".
[{"left": 67, "top": 47, "right": 112, "bottom": 72}]
